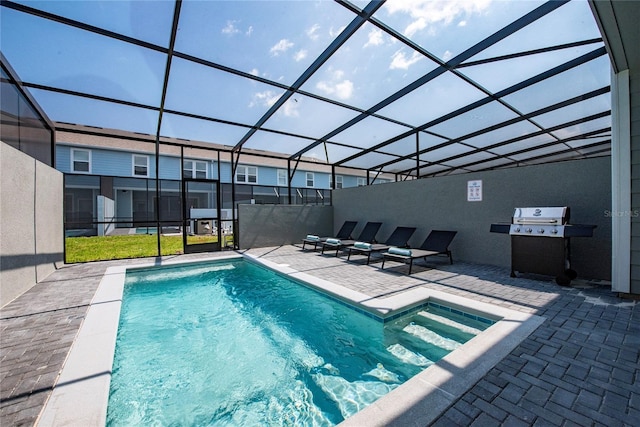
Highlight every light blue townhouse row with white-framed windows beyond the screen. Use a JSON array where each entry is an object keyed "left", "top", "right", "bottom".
[{"left": 55, "top": 124, "right": 395, "bottom": 236}]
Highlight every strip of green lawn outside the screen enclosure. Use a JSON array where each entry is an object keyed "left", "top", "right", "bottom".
[{"left": 65, "top": 234, "right": 230, "bottom": 263}]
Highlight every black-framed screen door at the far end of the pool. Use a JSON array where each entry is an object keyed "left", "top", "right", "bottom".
[{"left": 182, "top": 179, "right": 223, "bottom": 254}]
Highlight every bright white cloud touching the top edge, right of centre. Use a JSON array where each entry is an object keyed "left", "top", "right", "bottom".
[{"left": 384, "top": 0, "right": 492, "bottom": 37}]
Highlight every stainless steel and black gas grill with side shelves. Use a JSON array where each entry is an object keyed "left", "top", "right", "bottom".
[{"left": 491, "top": 206, "right": 596, "bottom": 285}]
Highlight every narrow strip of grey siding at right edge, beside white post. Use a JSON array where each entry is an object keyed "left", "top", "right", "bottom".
[{"left": 629, "top": 69, "right": 640, "bottom": 294}]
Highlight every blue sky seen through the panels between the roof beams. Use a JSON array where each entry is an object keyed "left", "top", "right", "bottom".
[{"left": 0, "top": 0, "right": 610, "bottom": 174}]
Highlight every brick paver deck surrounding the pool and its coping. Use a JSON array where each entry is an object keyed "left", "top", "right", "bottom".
[{"left": 0, "top": 246, "right": 640, "bottom": 427}]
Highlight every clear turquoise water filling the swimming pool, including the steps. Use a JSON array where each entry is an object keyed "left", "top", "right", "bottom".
[{"left": 107, "top": 261, "right": 488, "bottom": 426}]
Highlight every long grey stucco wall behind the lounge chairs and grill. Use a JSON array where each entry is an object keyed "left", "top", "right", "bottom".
[{"left": 332, "top": 157, "right": 611, "bottom": 280}]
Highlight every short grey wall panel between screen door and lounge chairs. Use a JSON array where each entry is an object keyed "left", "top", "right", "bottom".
[{"left": 238, "top": 205, "right": 332, "bottom": 249}]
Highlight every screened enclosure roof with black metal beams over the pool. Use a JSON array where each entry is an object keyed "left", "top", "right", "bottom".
[{"left": 0, "top": 0, "right": 611, "bottom": 177}]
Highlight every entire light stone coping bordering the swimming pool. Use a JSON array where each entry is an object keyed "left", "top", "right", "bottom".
[{"left": 36, "top": 253, "right": 544, "bottom": 427}]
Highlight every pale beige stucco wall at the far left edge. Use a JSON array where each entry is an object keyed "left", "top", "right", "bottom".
[{"left": 0, "top": 142, "right": 64, "bottom": 306}]
